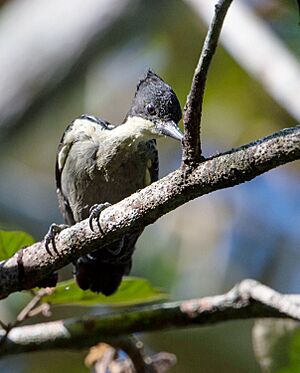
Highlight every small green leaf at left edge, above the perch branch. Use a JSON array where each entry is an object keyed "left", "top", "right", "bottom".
[{"left": 0, "top": 230, "right": 35, "bottom": 260}]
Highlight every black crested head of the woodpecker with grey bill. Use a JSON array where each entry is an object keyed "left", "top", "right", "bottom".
[{"left": 126, "top": 70, "right": 183, "bottom": 141}]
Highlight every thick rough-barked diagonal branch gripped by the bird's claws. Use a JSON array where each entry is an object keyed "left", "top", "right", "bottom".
[{"left": 0, "top": 126, "right": 300, "bottom": 298}]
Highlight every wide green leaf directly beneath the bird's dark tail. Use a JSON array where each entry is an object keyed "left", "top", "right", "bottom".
[{"left": 42, "top": 277, "right": 167, "bottom": 307}]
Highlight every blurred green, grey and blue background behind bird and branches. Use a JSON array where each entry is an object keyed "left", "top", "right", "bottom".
[{"left": 0, "top": 0, "right": 300, "bottom": 373}]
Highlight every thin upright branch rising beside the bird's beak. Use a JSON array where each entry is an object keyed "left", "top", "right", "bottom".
[{"left": 182, "top": 0, "right": 232, "bottom": 166}]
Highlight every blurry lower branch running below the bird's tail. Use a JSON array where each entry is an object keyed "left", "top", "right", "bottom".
[{"left": 0, "top": 280, "right": 300, "bottom": 356}]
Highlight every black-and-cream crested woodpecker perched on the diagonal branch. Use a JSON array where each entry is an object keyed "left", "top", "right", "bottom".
[{"left": 47, "top": 69, "right": 183, "bottom": 296}]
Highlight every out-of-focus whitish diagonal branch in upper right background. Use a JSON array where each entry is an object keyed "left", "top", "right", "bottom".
[{"left": 185, "top": 0, "right": 300, "bottom": 121}]
